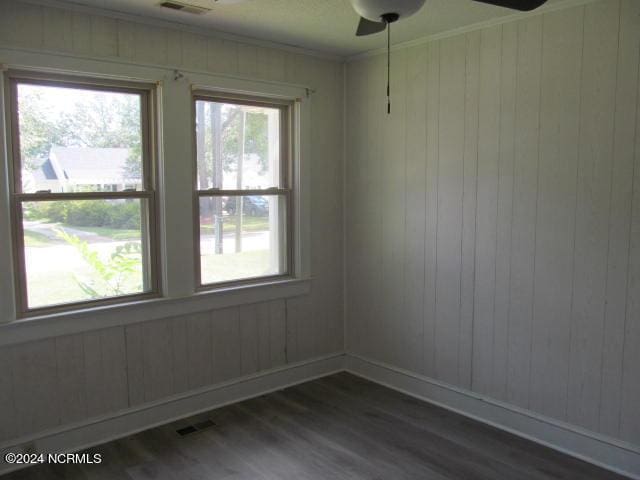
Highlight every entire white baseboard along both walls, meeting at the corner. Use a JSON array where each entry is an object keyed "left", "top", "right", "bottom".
[{"left": 0, "top": 354, "right": 640, "bottom": 480}]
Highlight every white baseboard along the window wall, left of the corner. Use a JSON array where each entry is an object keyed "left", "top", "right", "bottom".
[{"left": 0, "top": 354, "right": 344, "bottom": 475}]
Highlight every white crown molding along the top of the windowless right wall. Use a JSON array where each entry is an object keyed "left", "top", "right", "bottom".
[{"left": 345, "top": 0, "right": 600, "bottom": 63}]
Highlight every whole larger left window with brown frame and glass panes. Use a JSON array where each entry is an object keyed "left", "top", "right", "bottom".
[{"left": 8, "top": 72, "right": 159, "bottom": 315}]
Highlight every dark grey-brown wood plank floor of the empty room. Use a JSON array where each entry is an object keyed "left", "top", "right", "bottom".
[{"left": 3, "top": 373, "right": 623, "bottom": 480}]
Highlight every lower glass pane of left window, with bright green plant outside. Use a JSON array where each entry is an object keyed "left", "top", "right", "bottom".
[{"left": 23, "top": 199, "right": 149, "bottom": 308}]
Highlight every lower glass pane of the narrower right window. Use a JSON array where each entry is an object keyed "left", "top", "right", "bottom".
[{"left": 200, "top": 195, "right": 287, "bottom": 284}]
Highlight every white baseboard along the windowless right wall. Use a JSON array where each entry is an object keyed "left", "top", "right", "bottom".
[{"left": 345, "top": 354, "right": 640, "bottom": 480}]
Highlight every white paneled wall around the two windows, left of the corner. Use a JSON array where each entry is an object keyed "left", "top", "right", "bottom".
[{"left": 0, "top": 0, "right": 344, "bottom": 442}]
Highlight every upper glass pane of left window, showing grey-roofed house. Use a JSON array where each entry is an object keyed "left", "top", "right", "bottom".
[{"left": 17, "top": 83, "right": 143, "bottom": 193}]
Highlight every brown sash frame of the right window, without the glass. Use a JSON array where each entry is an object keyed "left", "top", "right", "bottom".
[{"left": 191, "top": 89, "right": 296, "bottom": 292}]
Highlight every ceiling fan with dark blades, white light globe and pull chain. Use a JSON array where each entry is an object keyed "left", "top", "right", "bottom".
[{"left": 351, "top": 0, "right": 547, "bottom": 113}]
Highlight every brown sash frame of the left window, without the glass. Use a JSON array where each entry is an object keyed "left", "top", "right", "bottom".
[{"left": 5, "top": 70, "right": 162, "bottom": 319}]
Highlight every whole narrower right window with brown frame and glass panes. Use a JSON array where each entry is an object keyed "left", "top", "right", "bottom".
[{"left": 194, "top": 93, "right": 293, "bottom": 287}]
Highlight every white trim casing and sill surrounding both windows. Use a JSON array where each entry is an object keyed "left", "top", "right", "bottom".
[{"left": 0, "top": 48, "right": 311, "bottom": 345}]
